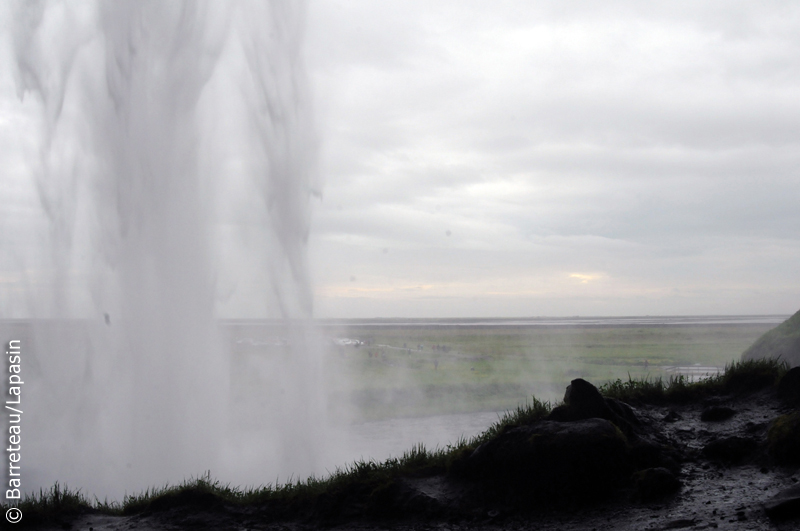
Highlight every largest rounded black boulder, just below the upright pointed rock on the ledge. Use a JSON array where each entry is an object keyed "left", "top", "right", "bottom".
[{"left": 463, "top": 418, "right": 631, "bottom": 501}]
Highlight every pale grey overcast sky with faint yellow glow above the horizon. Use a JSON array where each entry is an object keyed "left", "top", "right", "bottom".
[{"left": 0, "top": 0, "right": 800, "bottom": 317}]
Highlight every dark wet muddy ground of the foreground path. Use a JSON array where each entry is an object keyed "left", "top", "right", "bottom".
[{"left": 32, "top": 389, "right": 800, "bottom": 531}]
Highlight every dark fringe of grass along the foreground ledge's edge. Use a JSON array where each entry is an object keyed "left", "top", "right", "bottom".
[{"left": 6, "top": 359, "right": 787, "bottom": 525}]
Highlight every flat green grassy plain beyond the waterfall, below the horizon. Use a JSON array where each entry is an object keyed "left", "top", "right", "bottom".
[{"left": 316, "top": 324, "right": 774, "bottom": 419}]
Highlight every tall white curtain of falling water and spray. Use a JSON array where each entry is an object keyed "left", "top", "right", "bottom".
[{"left": 4, "top": 1, "right": 325, "bottom": 499}]
